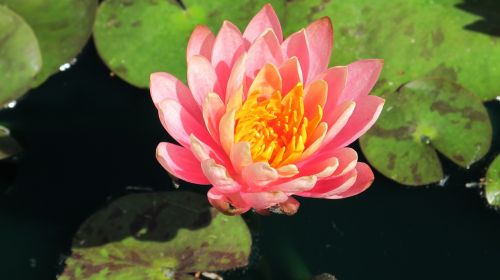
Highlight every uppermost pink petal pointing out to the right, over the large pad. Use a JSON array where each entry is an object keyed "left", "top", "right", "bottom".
[{"left": 337, "top": 59, "right": 384, "bottom": 104}]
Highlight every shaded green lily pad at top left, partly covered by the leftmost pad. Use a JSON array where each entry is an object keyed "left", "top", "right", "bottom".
[{"left": 0, "top": 0, "right": 97, "bottom": 87}]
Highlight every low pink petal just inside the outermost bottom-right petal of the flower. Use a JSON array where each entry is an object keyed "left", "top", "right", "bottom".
[{"left": 297, "top": 169, "right": 357, "bottom": 198}]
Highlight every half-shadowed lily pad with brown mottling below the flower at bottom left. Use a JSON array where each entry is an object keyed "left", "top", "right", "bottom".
[{"left": 60, "top": 192, "right": 252, "bottom": 280}]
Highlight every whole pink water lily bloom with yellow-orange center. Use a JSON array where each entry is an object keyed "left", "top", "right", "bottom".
[{"left": 151, "top": 5, "right": 384, "bottom": 214}]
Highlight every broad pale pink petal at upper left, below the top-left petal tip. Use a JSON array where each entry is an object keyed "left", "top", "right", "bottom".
[{"left": 187, "top": 55, "right": 221, "bottom": 108}]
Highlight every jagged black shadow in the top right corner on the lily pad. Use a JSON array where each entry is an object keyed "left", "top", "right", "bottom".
[{"left": 456, "top": 0, "right": 500, "bottom": 37}]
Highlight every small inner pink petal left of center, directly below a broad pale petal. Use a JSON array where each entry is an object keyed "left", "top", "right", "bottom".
[{"left": 202, "top": 92, "right": 226, "bottom": 143}]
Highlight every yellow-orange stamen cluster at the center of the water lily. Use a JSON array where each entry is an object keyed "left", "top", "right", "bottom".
[{"left": 234, "top": 83, "right": 323, "bottom": 167}]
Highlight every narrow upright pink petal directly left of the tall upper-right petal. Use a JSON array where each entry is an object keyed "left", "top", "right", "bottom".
[{"left": 281, "top": 29, "right": 310, "bottom": 83}]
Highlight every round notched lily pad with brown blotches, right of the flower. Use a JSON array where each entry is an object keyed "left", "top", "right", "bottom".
[{"left": 360, "top": 79, "right": 492, "bottom": 185}]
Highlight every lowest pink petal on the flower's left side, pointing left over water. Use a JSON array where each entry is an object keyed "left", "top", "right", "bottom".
[{"left": 156, "top": 142, "right": 210, "bottom": 185}]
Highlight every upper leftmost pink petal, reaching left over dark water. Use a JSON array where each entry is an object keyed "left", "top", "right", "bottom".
[{"left": 150, "top": 72, "right": 202, "bottom": 121}]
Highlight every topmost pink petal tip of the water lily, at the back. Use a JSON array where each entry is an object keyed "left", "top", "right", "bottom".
[{"left": 243, "top": 4, "right": 283, "bottom": 44}]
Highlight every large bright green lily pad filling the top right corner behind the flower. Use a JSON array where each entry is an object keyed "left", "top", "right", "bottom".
[{"left": 284, "top": 0, "right": 500, "bottom": 100}]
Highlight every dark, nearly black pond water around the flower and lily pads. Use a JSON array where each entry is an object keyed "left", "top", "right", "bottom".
[{"left": 0, "top": 40, "right": 500, "bottom": 280}]
